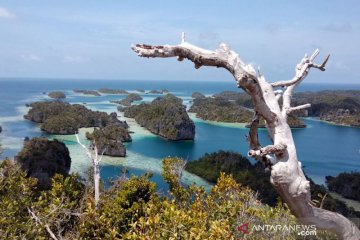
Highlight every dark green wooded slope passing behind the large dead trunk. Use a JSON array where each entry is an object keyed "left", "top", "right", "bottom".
[{"left": 186, "top": 151, "right": 360, "bottom": 225}]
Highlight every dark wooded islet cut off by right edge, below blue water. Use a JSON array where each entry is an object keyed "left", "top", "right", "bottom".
[{"left": 326, "top": 172, "right": 360, "bottom": 201}]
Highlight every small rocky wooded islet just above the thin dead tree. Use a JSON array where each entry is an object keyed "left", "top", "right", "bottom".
[{"left": 86, "top": 125, "right": 132, "bottom": 157}]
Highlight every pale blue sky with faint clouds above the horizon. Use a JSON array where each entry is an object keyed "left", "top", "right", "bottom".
[{"left": 0, "top": 0, "right": 360, "bottom": 83}]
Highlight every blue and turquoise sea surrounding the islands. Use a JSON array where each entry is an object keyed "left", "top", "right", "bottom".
[{"left": 0, "top": 78, "right": 360, "bottom": 193}]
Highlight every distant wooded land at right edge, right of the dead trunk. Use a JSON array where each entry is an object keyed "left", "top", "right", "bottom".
[{"left": 294, "top": 90, "right": 360, "bottom": 127}]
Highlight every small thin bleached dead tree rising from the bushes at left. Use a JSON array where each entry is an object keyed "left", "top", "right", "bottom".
[{"left": 75, "top": 134, "right": 105, "bottom": 207}]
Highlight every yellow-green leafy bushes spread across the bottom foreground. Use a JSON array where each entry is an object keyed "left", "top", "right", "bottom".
[{"left": 0, "top": 158, "right": 338, "bottom": 240}]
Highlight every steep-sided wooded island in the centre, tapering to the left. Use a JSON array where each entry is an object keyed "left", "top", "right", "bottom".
[{"left": 124, "top": 94, "right": 195, "bottom": 141}]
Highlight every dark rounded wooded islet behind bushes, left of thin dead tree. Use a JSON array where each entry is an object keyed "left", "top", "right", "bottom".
[{"left": 15, "top": 138, "right": 71, "bottom": 189}]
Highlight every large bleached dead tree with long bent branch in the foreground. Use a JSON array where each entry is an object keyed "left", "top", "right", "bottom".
[{"left": 132, "top": 33, "right": 360, "bottom": 240}]
